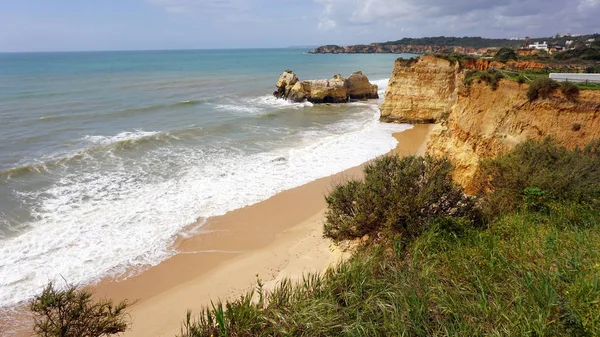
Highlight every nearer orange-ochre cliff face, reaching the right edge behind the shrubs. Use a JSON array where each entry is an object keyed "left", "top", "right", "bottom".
[{"left": 427, "top": 80, "right": 600, "bottom": 193}]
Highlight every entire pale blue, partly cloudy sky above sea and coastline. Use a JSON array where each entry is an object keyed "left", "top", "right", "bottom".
[{"left": 0, "top": 0, "right": 600, "bottom": 52}]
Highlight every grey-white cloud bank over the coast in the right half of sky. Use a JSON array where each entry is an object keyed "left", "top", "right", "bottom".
[{"left": 314, "top": 0, "right": 600, "bottom": 41}]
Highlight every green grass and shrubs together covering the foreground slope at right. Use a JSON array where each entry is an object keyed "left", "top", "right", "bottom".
[{"left": 181, "top": 140, "right": 600, "bottom": 337}]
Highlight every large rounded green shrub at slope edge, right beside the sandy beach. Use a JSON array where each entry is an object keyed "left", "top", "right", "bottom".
[{"left": 324, "top": 156, "right": 476, "bottom": 241}]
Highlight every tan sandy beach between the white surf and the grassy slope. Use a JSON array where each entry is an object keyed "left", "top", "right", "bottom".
[{"left": 10, "top": 125, "right": 431, "bottom": 337}]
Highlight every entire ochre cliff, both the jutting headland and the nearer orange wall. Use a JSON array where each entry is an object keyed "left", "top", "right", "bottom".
[{"left": 382, "top": 55, "right": 600, "bottom": 193}]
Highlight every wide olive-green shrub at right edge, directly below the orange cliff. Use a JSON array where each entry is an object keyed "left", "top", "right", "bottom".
[{"left": 478, "top": 138, "right": 600, "bottom": 217}]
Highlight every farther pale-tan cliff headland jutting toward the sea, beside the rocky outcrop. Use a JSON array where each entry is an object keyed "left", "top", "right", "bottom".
[{"left": 381, "top": 56, "right": 460, "bottom": 123}]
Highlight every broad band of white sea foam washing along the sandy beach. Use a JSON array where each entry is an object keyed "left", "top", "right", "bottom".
[{"left": 0, "top": 105, "right": 410, "bottom": 305}]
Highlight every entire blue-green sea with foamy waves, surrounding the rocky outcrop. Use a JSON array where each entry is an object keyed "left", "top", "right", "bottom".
[{"left": 0, "top": 49, "right": 408, "bottom": 306}]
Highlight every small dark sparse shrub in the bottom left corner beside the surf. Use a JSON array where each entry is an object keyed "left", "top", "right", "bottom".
[{"left": 29, "top": 283, "right": 131, "bottom": 337}]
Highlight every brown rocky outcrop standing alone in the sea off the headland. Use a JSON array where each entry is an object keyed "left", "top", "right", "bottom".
[{"left": 273, "top": 70, "right": 379, "bottom": 103}]
